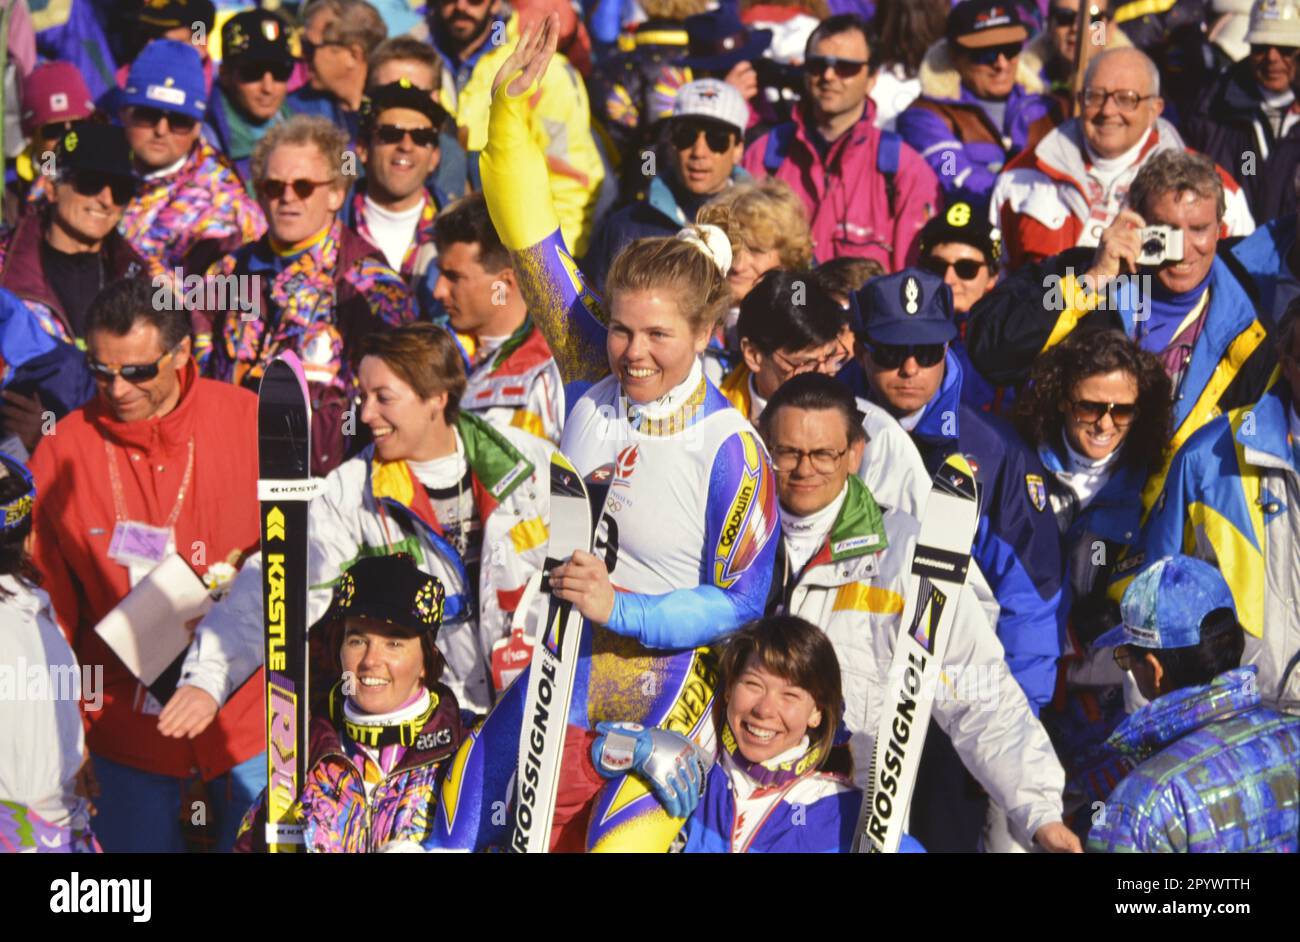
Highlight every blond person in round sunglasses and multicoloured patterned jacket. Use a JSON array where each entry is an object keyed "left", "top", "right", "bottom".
[{"left": 186, "top": 116, "right": 415, "bottom": 474}]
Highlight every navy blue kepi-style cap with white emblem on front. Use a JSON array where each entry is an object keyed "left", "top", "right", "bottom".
[{"left": 849, "top": 268, "right": 957, "bottom": 346}]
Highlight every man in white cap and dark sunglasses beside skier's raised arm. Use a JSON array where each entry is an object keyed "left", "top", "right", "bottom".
[{"left": 582, "top": 78, "right": 749, "bottom": 291}]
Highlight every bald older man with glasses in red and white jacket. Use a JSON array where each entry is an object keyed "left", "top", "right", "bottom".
[{"left": 991, "top": 48, "right": 1255, "bottom": 270}]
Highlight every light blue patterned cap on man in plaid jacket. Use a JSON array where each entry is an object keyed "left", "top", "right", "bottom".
[{"left": 1092, "top": 556, "right": 1236, "bottom": 650}]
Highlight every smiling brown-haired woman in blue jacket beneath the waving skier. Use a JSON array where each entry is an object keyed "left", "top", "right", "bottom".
[{"left": 589, "top": 616, "right": 923, "bottom": 854}]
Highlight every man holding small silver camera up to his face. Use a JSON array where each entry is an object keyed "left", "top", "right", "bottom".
[{"left": 966, "top": 149, "right": 1277, "bottom": 508}]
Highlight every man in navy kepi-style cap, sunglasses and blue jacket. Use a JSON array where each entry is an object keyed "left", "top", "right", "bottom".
[{"left": 853, "top": 269, "right": 1062, "bottom": 851}]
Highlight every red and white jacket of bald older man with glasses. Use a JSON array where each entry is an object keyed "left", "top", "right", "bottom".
[{"left": 989, "top": 118, "right": 1255, "bottom": 269}]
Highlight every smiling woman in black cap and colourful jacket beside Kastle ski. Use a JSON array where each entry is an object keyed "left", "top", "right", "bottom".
[{"left": 235, "top": 554, "right": 462, "bottom": 854}]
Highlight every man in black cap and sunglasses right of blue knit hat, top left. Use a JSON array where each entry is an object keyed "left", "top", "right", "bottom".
[{"left": 203, "top": 9, "right": 294, "bottom": 189}]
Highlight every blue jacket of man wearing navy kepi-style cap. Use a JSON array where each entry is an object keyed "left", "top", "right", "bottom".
[{"left": 873, "top": 350, "right": 1063, "bottom": 715}]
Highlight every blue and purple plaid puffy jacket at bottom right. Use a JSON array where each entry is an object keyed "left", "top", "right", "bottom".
[{"left": 1088, "top": 668, "right": 1300, "bottom": 854}]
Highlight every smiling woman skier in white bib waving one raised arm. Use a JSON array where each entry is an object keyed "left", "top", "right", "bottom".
[{"left": 439, "top": 14, "right": 777, "bottom": 851}]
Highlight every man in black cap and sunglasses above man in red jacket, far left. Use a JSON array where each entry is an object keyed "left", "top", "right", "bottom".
[{"left": 0, "top": 121, "right": 144, "bottom": 452}]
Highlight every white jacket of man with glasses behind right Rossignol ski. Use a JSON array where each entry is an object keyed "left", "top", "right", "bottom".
[{"left": 787, "top": 477, "right": 1065, "bottom": 843}]
